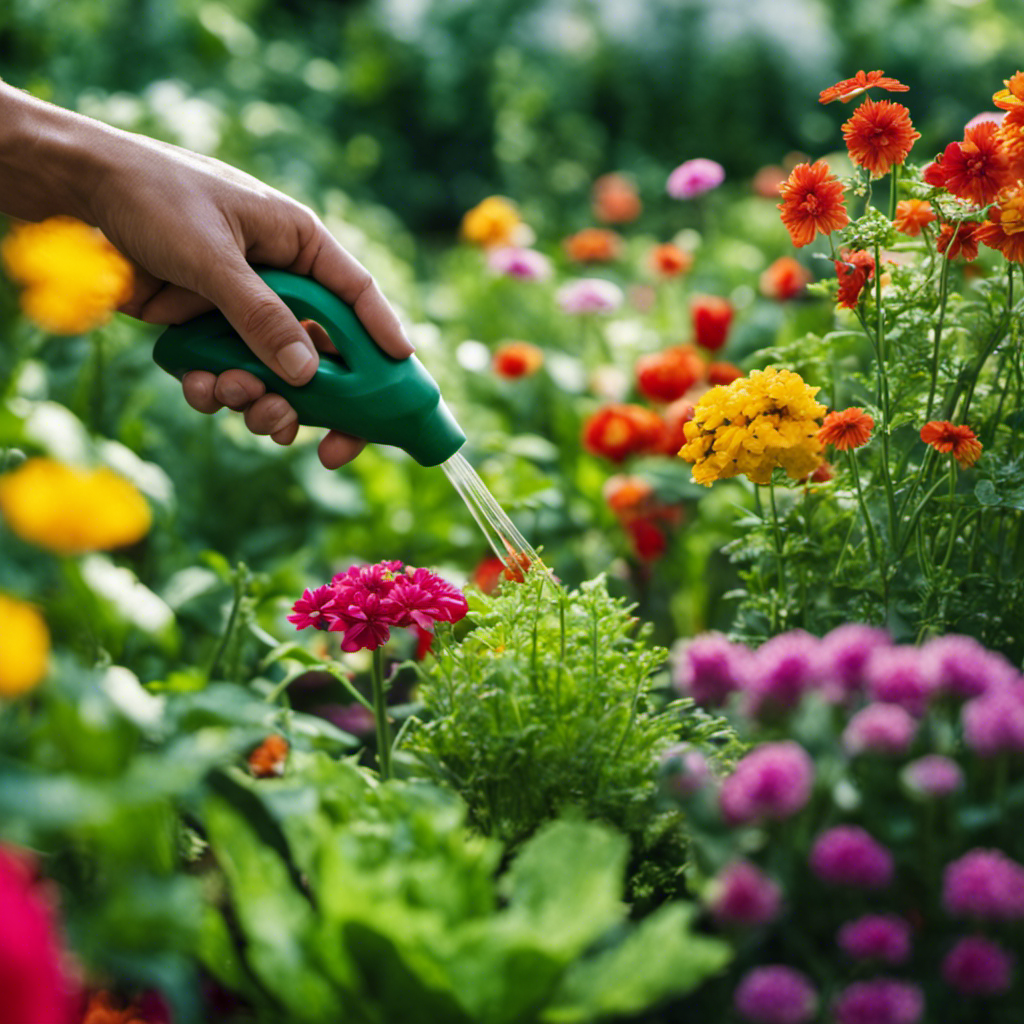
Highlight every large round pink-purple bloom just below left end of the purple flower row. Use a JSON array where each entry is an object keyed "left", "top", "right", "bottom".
[{"left": 720, "top": 740, "right": 814, "bottom": 824}]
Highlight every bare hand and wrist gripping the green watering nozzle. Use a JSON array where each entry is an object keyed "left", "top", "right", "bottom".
[{"left": 0, "top": 82, "right": 413, "bottom": 469}]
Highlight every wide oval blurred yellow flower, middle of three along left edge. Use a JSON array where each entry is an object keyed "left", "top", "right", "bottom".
[{"left": 0, "top": 459, "right": 153, "bottom": 555}]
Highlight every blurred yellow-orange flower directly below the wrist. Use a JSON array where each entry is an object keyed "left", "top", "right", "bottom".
[{"left": 0, "top": 217, "right": 132, "bottom": 334}]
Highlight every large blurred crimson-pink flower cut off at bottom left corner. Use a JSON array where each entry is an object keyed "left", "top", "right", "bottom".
[{"left": 0, "top": 847, "right": 78, "bottom": 1024}]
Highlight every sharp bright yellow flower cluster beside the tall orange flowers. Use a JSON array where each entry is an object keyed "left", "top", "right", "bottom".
[{"left": 679, "top": 367, "right": 825, "bottom": 486}]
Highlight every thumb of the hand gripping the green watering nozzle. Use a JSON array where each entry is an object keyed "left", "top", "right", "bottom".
[{"left": 204, "top": 262, "right": 319, "bottom": 384}]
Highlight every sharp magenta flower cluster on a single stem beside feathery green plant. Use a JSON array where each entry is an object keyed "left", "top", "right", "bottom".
[{"left": 288, "top": 561, "right": 469, "bottom": 652}]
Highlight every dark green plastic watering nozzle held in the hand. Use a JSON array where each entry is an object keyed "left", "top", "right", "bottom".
[{"left": 153, "top": 268, "right": 466, "bottom": 466}]
